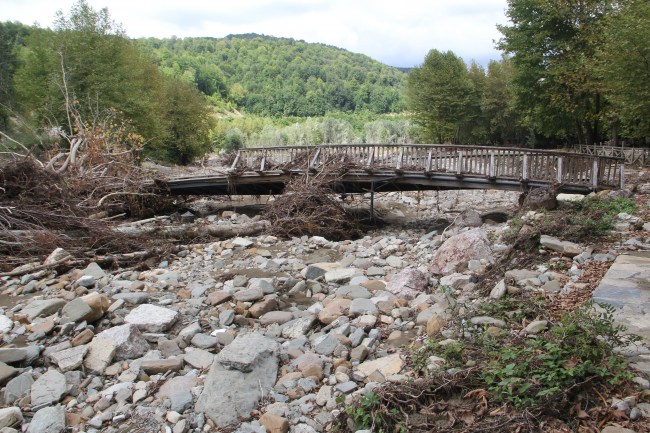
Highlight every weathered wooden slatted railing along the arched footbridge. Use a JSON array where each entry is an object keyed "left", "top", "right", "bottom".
[{"left": 231, "top": 144, "right": 624, "bottom": 189}]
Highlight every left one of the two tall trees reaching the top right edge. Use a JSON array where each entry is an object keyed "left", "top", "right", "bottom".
[{"left": 498, "top": 0, "right": 615, "bottom": 144}]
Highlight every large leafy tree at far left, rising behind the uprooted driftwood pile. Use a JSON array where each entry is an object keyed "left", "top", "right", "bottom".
[{"left": 16, "top": 0, "right": 162, "bottom": 138}]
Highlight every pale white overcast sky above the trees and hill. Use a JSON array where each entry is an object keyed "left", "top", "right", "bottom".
[{"left": 0, "top": 0, "right": 507, "bottom": 67}]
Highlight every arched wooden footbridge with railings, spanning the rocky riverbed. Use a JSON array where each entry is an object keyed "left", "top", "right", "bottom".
[{"left": 167, "top": 144, "right": 625, "bottom": 195}]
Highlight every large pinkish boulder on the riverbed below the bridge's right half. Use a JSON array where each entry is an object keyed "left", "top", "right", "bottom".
[{"left": 430, "top": 229, "right": 490, "bottom": 275}]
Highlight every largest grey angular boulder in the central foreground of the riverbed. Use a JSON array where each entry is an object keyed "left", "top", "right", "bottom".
[{"left": 195, "top": 332, "right": 280, "bottom": 428}]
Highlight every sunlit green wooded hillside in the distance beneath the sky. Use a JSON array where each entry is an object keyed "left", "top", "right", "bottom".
[{"left": 139, "top": 33, "right": 406, "bottom": 117}]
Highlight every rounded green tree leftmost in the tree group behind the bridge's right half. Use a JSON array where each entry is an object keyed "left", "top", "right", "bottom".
[{"left": 406, "top": 50, "right": 473, "bottom": 143}]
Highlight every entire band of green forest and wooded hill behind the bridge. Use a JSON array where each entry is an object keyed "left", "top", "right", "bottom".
[{"left": 0, "top": 0, "right": 650, "bottom": 163}]
